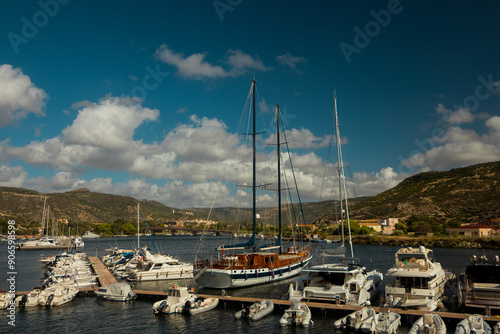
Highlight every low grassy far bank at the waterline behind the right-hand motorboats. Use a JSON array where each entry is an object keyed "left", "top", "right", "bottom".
[{"left": 352, "top": 235, "right": 500, "bottom": 249}]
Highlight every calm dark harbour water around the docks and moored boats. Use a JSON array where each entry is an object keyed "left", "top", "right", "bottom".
[{"left": 0, "top": 236, "right": 498, "bottom": 333}]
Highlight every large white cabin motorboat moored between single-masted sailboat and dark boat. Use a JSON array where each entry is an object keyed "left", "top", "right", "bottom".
[{"left": 385, "top": 246, "right": 453, "bottom": 311}]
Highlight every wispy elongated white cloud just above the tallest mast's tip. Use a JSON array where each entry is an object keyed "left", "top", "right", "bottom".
[{"left": 155, "top": 45, "right": 267, "bottom": 79}]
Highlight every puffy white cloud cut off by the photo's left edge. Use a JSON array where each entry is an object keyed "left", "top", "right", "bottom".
[{"left": 0, "top": 64, "right": 48, "bottom": 129}]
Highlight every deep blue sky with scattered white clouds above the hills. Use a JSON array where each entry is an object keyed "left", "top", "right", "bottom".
[{"left": 0, "top": 0, "right": 500, "bottom": 208}]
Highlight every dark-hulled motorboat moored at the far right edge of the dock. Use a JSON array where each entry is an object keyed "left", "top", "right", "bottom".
[{"left": 457, "top": 255, "right": 500, "bottom": 309}]
